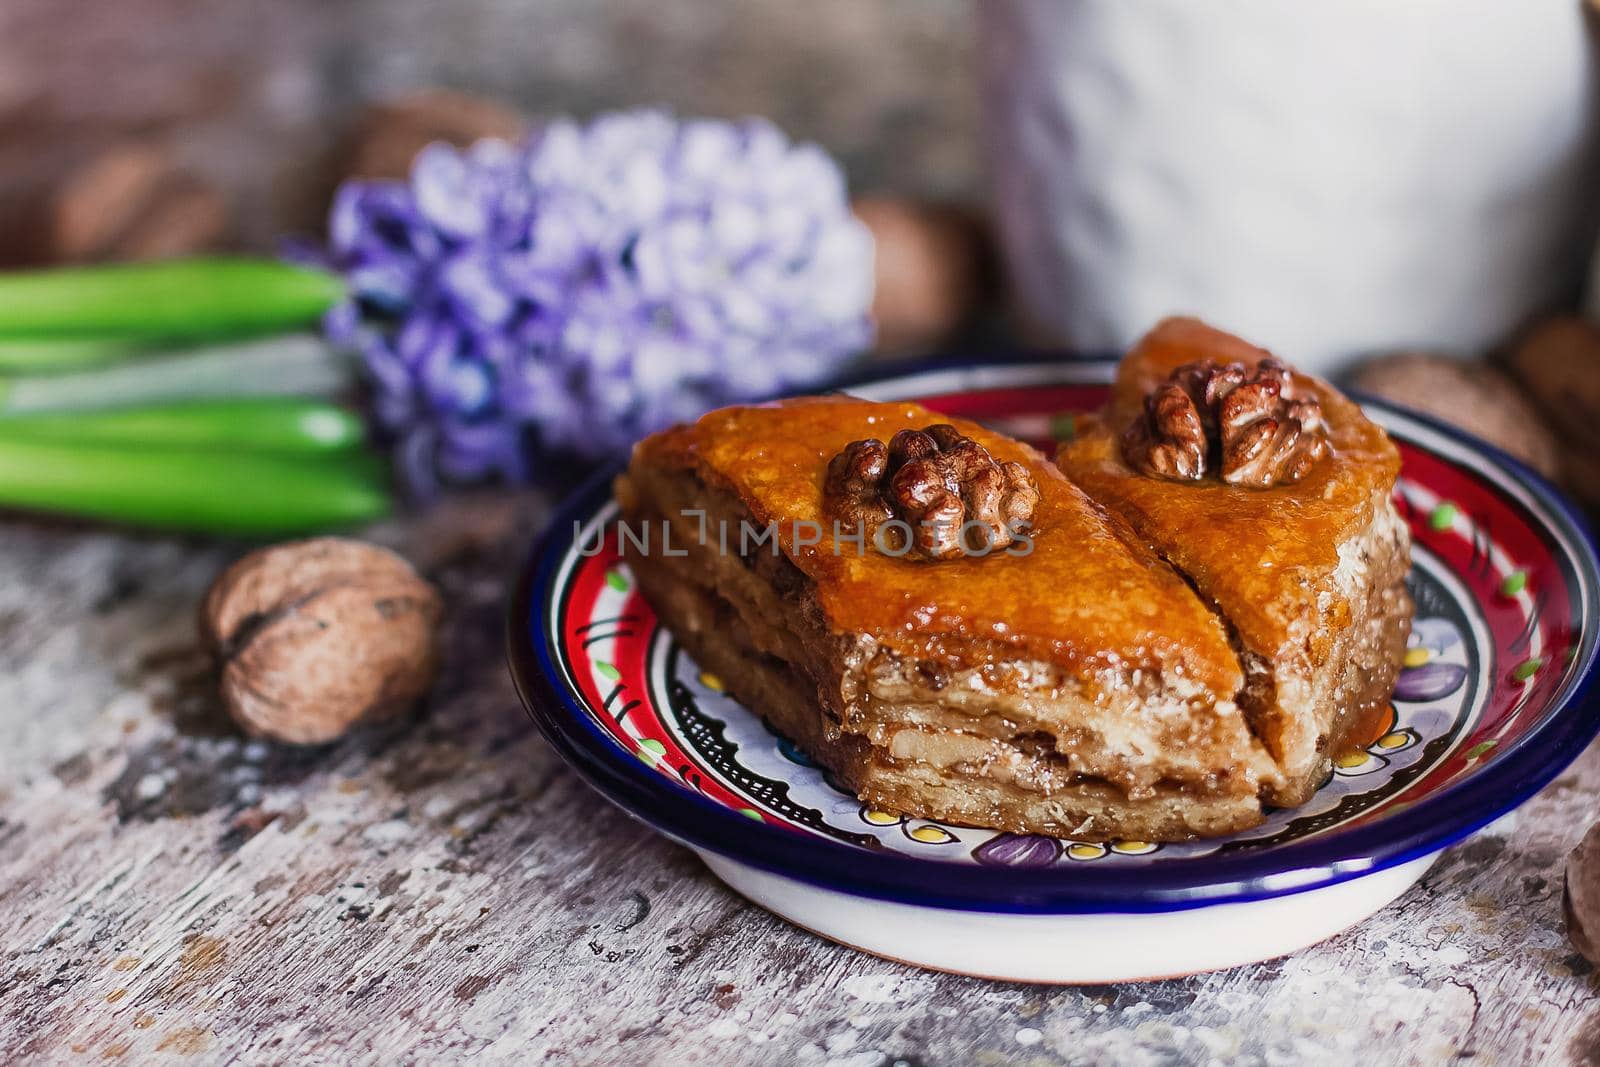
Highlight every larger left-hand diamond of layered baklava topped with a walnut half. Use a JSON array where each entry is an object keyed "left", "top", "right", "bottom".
[{"left": 616, "top": 398, "right": 1283, "bottom": 840}]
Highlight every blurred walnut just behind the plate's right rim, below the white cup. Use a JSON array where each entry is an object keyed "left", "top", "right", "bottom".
[{"left": 1350, "top": 352, "right": 1562, "bottom": 478}]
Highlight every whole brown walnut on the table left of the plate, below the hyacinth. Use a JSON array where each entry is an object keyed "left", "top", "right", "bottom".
[{"left": 200, "top": 537, "right": 442, "bottom": 744}]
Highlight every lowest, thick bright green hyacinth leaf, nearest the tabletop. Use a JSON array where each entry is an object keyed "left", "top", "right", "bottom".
[{"left": 0, "top": 440, "right": 390, "bottom": 536}]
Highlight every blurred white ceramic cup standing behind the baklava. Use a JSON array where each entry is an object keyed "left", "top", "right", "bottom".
[{"left": 978, "top": 0, "right": 1600, "bottom": 373}]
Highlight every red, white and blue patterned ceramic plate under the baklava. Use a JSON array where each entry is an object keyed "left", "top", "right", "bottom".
[{"left": 510, "top": 362, "right": 1600, "bottom": 982}]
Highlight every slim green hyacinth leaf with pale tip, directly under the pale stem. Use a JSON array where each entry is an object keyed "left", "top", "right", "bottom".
[{"left": 0, "top": 397, "right": 366, "bottom": 453}]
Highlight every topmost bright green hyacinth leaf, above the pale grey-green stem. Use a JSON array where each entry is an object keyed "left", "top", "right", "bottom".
[{"left": 0, "top": 258, "right": 344, "bottom": 341}]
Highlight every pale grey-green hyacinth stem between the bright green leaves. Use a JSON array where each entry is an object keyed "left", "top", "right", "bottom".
[{"left": 0, "top": 334, "right": 355, "bottom": 414}]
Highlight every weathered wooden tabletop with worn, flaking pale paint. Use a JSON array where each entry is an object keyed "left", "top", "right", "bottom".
[{"left": 0, "top": 499, "right": 1600, "bottom": 1067}]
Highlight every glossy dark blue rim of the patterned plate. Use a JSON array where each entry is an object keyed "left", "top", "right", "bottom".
[{"left": 507, "top": 354, "right": 1600, "bottom": 915}]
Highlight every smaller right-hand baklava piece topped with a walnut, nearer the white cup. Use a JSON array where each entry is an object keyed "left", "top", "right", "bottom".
[{"left": 1058, "top": 318, "right": 1411, "bottom": 806}]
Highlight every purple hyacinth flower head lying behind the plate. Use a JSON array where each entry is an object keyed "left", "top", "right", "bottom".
[{"left": 326, "top": 110, "right": 872, "bottom": 490}]
